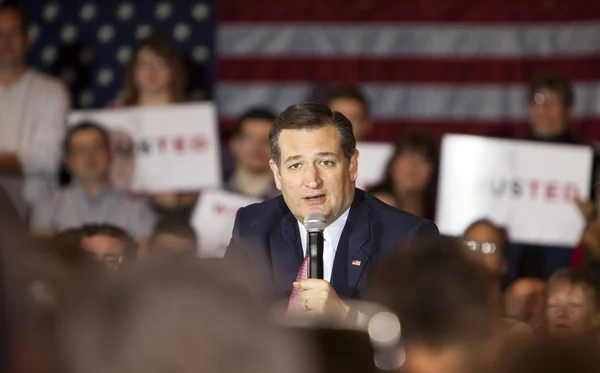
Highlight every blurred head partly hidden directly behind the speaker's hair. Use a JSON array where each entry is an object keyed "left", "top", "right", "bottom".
[{"left": 325, "top": 85, "right": 373, "bottom": 142}]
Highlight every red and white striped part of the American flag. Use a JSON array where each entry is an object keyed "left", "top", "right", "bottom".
[{"left": 217, "top": 0, "right": 600, "bottom": 141}]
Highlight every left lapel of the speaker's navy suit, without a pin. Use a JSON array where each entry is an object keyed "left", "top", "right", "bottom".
[{"left": 269, "top": 212, "right": 303, "bottom": 295}]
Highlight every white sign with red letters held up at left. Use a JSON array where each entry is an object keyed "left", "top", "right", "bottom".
[{"left": 69, "top": 103, "right": 221, "bottom": 192}]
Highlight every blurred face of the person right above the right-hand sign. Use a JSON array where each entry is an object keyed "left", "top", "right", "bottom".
[{"left": 529, "top": 89, "right": 571, "bottom": 139}]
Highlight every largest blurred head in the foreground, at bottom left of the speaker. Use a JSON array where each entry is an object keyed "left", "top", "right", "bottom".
[{"left": 61, "top": 261, "right": 309, "bottom": 373}]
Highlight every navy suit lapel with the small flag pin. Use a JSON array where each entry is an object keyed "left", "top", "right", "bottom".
[{"left": 332, "top": 190, "right": 374, "bottom": 298}]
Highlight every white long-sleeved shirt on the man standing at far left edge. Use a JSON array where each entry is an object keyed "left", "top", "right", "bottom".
[{"left": 0, "top": 69, "right": 70, "bottom": 212}]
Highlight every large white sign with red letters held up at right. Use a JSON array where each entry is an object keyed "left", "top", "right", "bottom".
[{"left": 436, "top": 135, "right": 593, "bottom": 247}]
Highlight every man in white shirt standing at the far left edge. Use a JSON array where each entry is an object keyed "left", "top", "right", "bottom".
[{"left": 0, "top": 2, "right": 70, "bottom": 216}]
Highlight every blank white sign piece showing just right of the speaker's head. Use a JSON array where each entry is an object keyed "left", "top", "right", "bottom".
[{"left": 356, "top": 142, "right": 394, "bottom": 190}]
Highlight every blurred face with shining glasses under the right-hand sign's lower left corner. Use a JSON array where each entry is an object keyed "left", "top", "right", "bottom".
[{"left": 464, "top": 224, "right": 507, "bottom": 277}]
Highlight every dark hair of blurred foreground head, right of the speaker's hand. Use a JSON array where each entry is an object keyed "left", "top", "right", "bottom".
[{"left": 367, "top": 237, "right": 493, "bottom": 348}]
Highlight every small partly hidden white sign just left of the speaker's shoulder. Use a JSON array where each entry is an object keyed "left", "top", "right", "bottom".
[{"left": 192, "top": 190, "right": 260, "bottom": 258}]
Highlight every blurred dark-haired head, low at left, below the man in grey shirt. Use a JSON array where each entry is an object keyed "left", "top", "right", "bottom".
[{"left": 79, "top": 224, "right": 137, "bottom": 271}]
